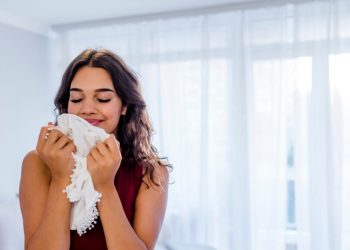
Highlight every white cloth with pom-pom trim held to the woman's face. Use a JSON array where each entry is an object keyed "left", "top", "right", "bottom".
[{"left": 56, "top": 114, "right": 109, "bottom": 235}]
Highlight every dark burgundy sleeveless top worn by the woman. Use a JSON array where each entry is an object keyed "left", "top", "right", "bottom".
[{"left": 70, "top": 161, "right": 142, "bottom": 250}]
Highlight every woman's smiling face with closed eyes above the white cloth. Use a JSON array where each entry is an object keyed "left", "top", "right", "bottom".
[{"left": 68, "top": 66, "right": 126, "bottom": 133}]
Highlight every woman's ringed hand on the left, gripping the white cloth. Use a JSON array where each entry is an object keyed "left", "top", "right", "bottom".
[{"left": 36, "top": 123, "right": 76, "bottom": 184}]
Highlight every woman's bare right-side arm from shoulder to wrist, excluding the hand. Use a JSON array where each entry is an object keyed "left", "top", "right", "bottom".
[{"left": 99, "top": 167, "right": 168, "bottom": 250}]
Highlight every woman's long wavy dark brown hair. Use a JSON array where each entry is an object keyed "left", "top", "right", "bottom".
[{"left": 54, "top": 49, "right": 172, "bottom": 185}]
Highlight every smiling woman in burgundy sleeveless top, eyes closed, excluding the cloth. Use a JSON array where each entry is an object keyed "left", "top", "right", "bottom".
[{"left": 20, "top": 49, "right": 170, "bottom": 250}]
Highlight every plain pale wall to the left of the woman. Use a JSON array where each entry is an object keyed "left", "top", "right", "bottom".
[{"left": 0, "top": 23, "right": 54, "bottom": 250}]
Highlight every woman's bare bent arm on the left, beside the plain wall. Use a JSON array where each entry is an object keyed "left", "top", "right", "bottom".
[{"left": 20, "top": 128, "right": 75, "bottom": 250}]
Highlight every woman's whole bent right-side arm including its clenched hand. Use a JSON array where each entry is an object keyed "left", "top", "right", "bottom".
[{"left": 88, "top": 137, "right": 168, "bottom": 250}]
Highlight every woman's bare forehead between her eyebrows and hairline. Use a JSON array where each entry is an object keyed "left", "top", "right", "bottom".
[{"left": 71, "top": 66, "right": 114, "bottom": 91}]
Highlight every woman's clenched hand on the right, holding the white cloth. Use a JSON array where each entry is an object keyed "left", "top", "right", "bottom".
[{"left": 87, "top": 135, "right": 122, "bottom": 191}]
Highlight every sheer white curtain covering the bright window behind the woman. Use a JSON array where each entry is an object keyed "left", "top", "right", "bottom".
[{"left": 52, "top": 1, "right": 350, "bottom": 250}]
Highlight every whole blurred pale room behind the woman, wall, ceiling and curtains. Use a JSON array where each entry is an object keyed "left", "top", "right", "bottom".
[{"left": 0, "top": 0, "right": 350, "bottom": 250}]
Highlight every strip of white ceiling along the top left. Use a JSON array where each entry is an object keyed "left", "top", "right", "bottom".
[{"left": 0, "top": 0, "right": 261, "bottom": 27}]
